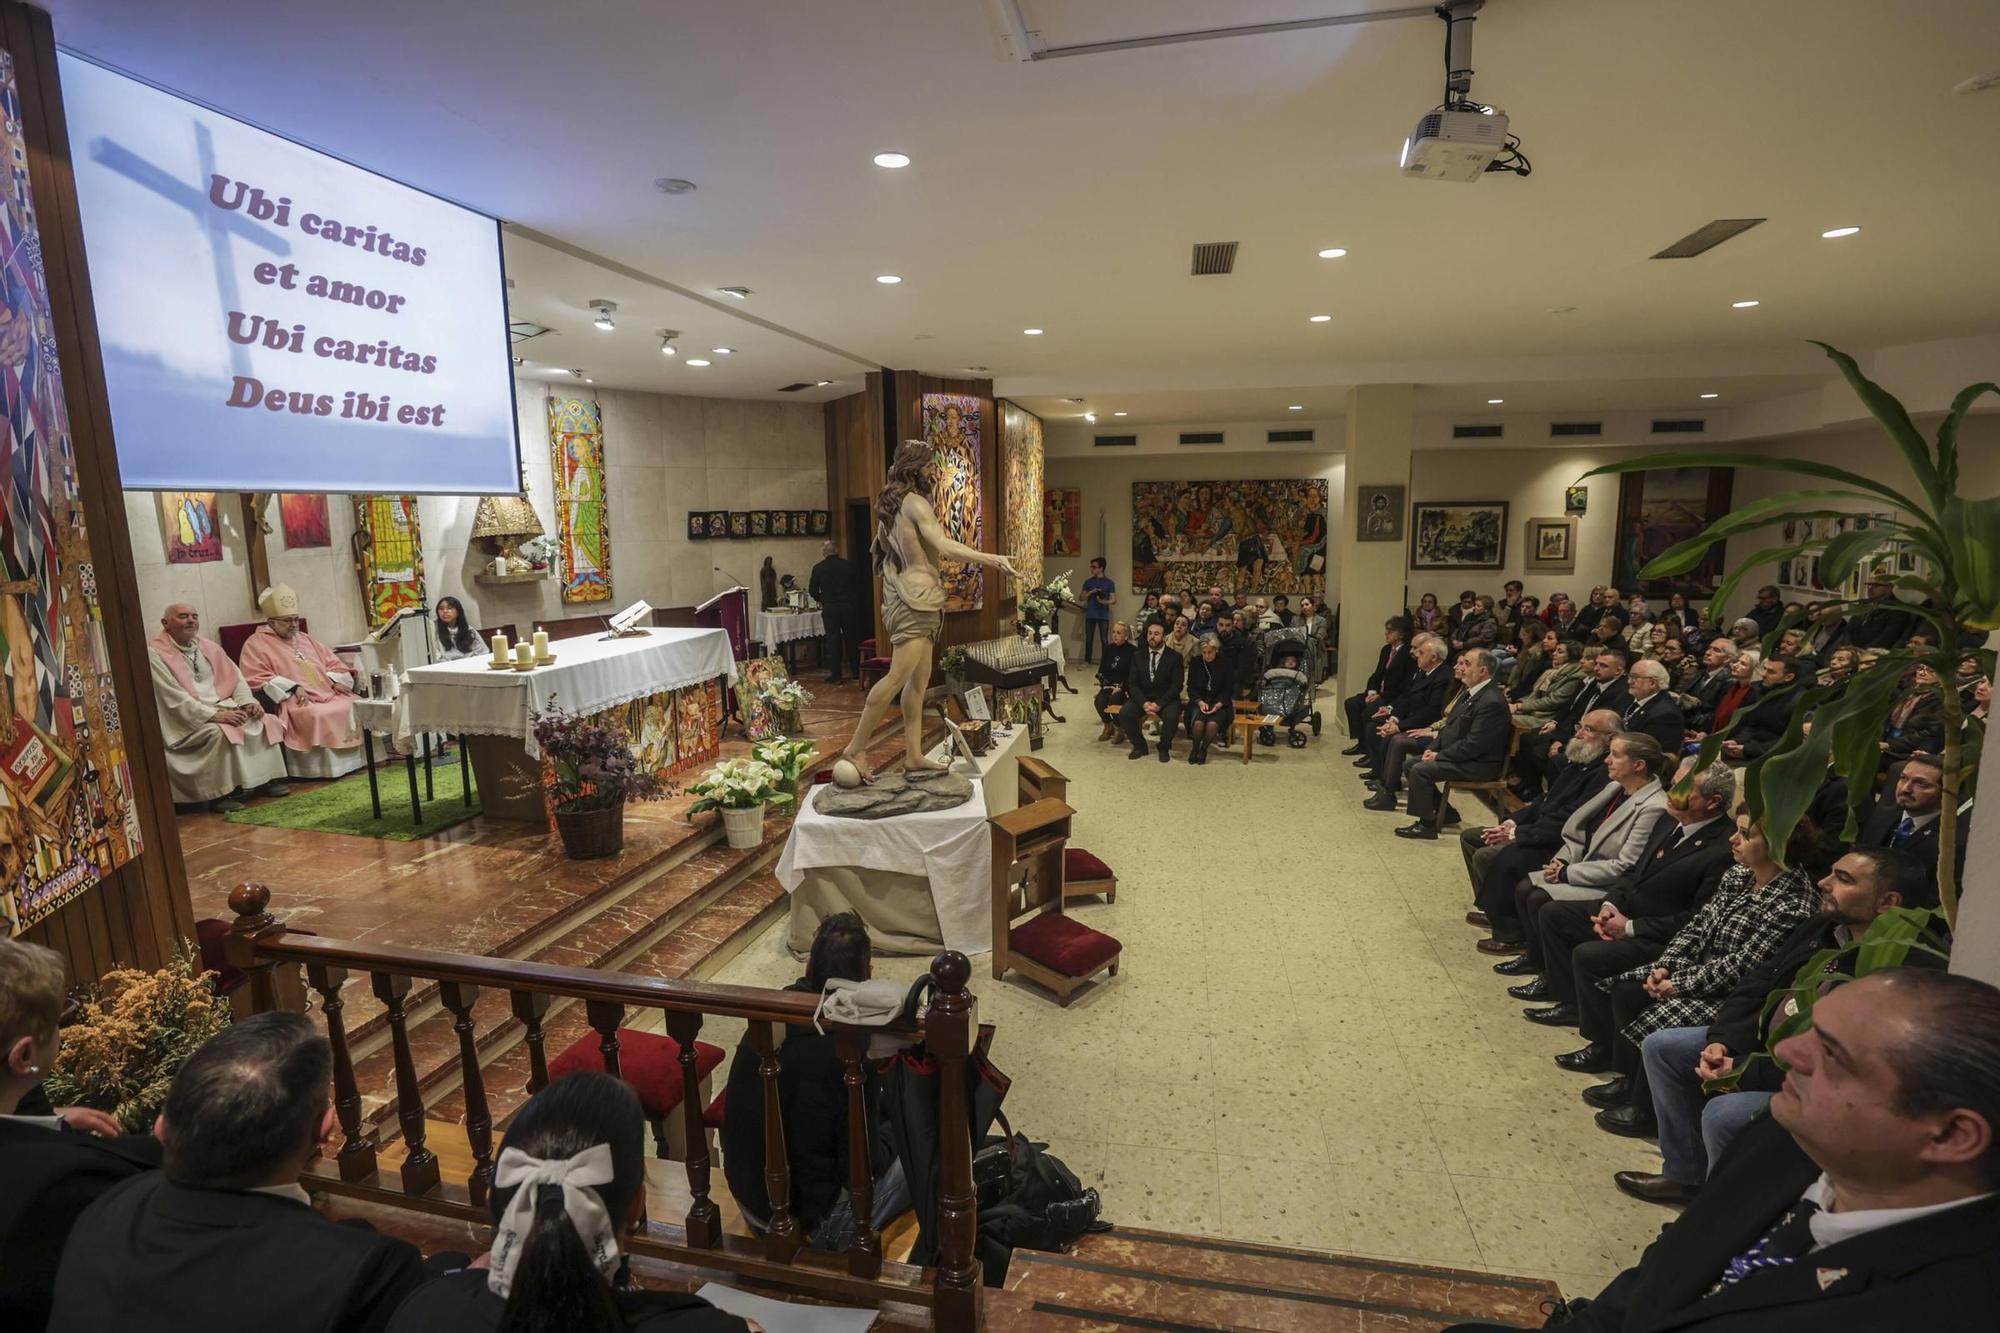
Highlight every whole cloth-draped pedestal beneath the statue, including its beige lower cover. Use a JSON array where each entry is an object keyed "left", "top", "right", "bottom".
[{"left": 778, "top": 779, "right": 1012, "bottom": 955}]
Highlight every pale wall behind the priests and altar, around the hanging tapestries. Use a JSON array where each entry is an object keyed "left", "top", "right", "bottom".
[{"left": 126, "top": 382, "right": 826, "bottom": 642}]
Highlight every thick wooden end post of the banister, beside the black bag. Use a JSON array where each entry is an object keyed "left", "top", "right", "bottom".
[{"left": 918, "top": 949, "right": 984, "bottom": 1333}]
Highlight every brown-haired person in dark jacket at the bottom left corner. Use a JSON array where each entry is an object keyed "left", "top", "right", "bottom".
[{"left": 0, "top": 939, "right": 160, "bottom": 1329}]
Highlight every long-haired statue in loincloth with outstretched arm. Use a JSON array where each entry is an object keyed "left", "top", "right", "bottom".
[{"left": 834, "top": 440, "right": 1014, "bottom": 787}]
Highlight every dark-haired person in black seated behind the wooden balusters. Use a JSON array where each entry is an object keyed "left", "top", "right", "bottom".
[{"left": 722, "top": 913, "right": 910, "bottom": 1253}]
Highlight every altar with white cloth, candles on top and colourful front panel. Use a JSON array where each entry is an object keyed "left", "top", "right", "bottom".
[{"left": 402, "top": 626, "right": 736, "bottom": 823}]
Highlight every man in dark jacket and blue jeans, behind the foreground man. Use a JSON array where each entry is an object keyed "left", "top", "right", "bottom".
[{"left": 1624, "top": 847, "right": 1944, "bottom": 1203}]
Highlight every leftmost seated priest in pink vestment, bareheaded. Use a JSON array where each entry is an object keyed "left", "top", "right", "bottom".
[{"left": 146, "top": 602, "right": 288, "bottom": 813}]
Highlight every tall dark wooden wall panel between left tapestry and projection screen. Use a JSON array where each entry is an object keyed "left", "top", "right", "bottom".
[{"left": 0, "top": 0, "right": 194, "bottom": 981}]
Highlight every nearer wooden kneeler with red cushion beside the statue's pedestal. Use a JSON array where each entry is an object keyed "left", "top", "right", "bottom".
[{"left": 986, "top": 797, "right": 1120, "bottom": 1007}]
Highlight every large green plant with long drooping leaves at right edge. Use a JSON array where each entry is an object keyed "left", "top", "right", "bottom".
[{"left": 1578, "top": 342, "right": 2000, "bottom": 927}]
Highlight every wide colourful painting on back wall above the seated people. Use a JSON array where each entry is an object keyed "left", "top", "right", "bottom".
[{"left": 1132, "top": 476, "right": 1326, "bottom": 594}]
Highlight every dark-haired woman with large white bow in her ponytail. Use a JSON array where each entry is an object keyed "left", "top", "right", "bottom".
[{"left": 388, "top": 1073, "right": 758, "bottom": 1333}]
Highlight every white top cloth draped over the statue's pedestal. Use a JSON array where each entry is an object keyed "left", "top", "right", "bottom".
[{"left": 778, "top": 785, "right": 994, "bottom": 955}]
